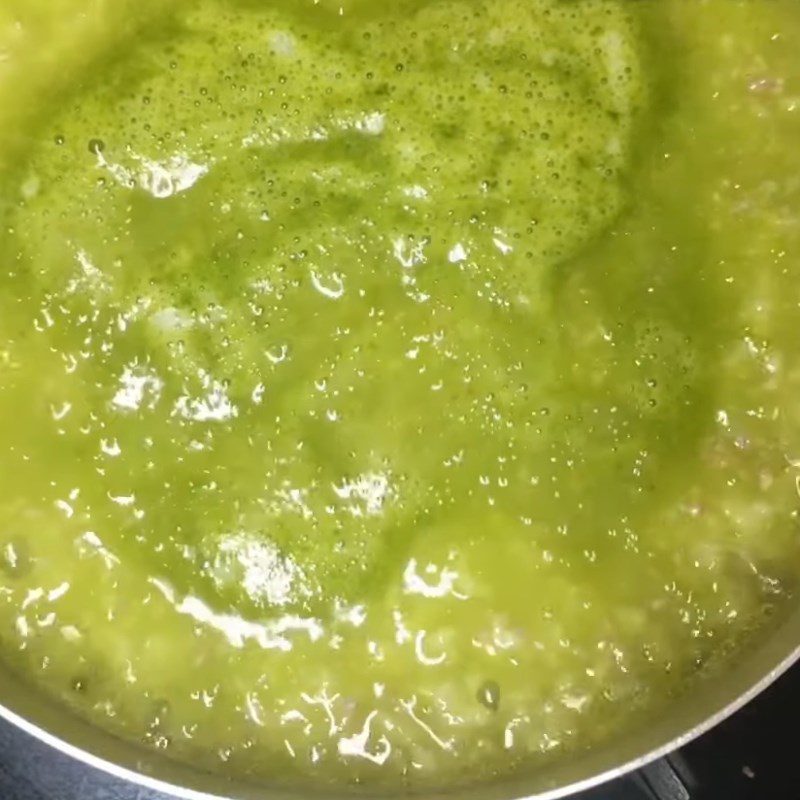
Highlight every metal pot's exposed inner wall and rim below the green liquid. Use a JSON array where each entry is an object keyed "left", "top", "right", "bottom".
[{"left": 0, "top": 1, "right": 800, "bottom": 800}]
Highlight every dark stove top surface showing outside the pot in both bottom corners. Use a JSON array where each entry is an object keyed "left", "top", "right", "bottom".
[{"left": 0, "top": 664, "right": 800, "bottom": 800}]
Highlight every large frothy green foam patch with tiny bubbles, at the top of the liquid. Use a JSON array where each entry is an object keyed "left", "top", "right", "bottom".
[{"left": 9, "top": 0, "right": 644, "bottom": 303}]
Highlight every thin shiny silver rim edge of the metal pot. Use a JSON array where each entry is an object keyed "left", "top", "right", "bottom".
[{"left": 0, "top": 645, "right": 800, "bottom": 800}]
